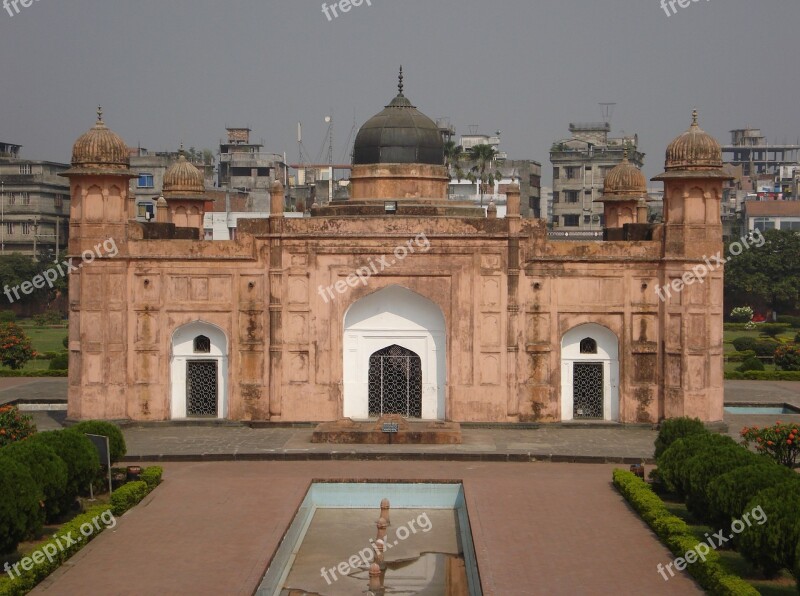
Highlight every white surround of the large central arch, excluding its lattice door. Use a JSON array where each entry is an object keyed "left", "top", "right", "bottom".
[{"left": 342, "top": 286, "right": 447, "bottom": 420}]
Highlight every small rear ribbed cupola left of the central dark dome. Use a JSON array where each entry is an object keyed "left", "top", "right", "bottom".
[{"left": 163, "top": 146, "right": 206, "bottom": 230}]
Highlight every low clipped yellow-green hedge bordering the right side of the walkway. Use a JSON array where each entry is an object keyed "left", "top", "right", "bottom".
[{"left": 613, "top": 469, "right": 758, "bottom": 596}]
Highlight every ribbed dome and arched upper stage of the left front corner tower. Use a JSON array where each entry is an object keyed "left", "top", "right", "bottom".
[{"left": 61, "top": 107, "right": 135, "bottom": 255}]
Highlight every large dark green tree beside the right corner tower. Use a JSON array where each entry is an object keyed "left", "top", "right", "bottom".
[{"left": 725, "top": 230, "right": 800, "bottom": 312}]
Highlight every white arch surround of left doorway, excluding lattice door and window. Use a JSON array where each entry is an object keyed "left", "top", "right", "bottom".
[{"left": 170, "top": 321, "right": 228, "bottom": 420}]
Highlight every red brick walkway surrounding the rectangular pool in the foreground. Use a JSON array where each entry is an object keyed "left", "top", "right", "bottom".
[{"left": 33, "top": 461, "right": 702, "bottom": 596}]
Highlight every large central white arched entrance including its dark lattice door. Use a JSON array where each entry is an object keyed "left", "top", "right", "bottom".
[{"left": 343, "top": 286, "right": 447, "bottom": 420}]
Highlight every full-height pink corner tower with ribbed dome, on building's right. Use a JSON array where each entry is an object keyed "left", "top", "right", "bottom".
[{"left": 653, "top": 111, "right": 729, "bottom": 421}]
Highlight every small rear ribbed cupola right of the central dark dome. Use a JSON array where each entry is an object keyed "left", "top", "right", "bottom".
[{"left": 597, "top": 147, "right": 647, "bottom": 229}]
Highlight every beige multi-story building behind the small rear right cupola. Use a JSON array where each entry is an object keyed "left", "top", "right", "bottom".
[{"left": 550, "top": 122, "right": 644, "bottom": 233}]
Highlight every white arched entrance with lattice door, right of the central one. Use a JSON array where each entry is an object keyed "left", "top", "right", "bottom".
[{"left": 561, "top": 323, "right": 619, "bottom": 421}]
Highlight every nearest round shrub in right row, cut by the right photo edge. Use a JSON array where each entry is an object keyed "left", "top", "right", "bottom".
[{"left": 738, "top": 481, "right": 800, "bottom": 577}]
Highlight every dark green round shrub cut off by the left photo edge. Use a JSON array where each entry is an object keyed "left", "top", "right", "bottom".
[{"left": 0, "top": 457, "right": 44, "bottom": 554}]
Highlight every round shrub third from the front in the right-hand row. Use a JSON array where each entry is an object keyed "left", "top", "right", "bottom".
[{"left": 686, "top": 445, "right": 762, "bottom": 521}]
